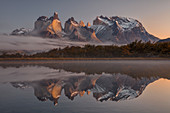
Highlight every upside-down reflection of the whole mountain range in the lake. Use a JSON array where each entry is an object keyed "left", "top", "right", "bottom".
[{"left": 11, "top": 74, "right": 158, "bottom": 105}]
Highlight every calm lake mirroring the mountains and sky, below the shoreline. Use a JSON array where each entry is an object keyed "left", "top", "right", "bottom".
[{"left": 0, "top": 60, "right": 170, "bottom": 113}]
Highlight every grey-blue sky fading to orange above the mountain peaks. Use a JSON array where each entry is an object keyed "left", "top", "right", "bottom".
[{"left": 0, "top": 0, "right": 170, "bottom": 39}]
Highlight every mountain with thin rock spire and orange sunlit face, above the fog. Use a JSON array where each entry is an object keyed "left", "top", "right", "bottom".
[{"left": 33, "top": 12, "right": 62, "bottom": 37}]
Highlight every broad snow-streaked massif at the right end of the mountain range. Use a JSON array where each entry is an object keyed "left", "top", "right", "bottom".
[{"left": 91, "top": 16, "right": 159, "bottom": 44}]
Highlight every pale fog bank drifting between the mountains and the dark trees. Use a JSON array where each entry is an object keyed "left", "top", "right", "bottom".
[{"left": 0, "top": 35, "right": 119, "bottom": 54}]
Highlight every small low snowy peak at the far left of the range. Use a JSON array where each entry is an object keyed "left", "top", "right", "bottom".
[{"left": 11, "top": 28, "right": 30, "bottom": 36}]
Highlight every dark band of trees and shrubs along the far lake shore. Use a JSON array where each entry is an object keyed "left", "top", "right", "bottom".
[{"left": 0, "top": 41, "right": 170, "bottom": 58}]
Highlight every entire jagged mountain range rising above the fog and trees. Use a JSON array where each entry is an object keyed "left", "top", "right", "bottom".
[{"left": 11, "top": 12, "right": 159, "bottom": 44}]
